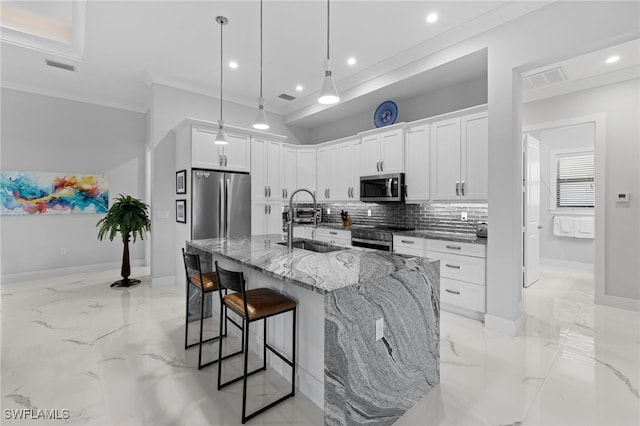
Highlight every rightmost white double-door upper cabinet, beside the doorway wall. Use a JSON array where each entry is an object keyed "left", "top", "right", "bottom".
[{"left": 431, "top": 112, "right": 489, "bottom": 201}]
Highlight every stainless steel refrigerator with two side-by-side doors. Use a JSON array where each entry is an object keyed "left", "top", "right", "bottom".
[{"left": 191, "top": 169, "right": 251, "bottom": 240}]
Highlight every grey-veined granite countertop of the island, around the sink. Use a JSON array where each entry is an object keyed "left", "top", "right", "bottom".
[{"left": 187, "top": 235, "right": 435, "bottom": 293}]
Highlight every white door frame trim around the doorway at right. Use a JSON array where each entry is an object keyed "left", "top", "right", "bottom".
[{"left": 522, "top": 112, "right": 608, "bottom": 309}]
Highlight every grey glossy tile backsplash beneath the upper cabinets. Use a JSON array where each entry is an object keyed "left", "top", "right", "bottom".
[{"left": 302, "top": 203, "right": 488, "bottom": 234}]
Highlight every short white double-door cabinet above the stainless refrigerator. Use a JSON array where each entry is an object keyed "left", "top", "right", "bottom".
[{"left": 191, "top": 126, "right": 250, "bottom": 172}]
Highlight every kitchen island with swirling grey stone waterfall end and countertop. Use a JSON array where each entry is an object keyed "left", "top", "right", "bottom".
[{"left": 187, "top": 235, "right": 440, "bottom": 425}]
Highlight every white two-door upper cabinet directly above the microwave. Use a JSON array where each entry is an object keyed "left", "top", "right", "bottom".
[{"left": 362, "top": 127, "right": 404, "bottom": 176}]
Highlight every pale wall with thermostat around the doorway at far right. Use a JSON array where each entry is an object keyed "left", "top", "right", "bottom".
[{"left": 523, "top": 79, "right": 640, "bottom": 300}]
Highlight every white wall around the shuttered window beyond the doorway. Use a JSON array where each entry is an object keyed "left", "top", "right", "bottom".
[{"left": 523, "top": 121, "right": 595, "bottom": 264}]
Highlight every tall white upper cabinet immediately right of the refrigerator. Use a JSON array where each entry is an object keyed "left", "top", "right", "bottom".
[{"left": 251, "top": 137, "right": 282, "bottom": 201}]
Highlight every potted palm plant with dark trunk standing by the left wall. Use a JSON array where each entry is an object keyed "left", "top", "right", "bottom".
[{"left": 96, "top": 194, "right": 151, "bottom": 287}]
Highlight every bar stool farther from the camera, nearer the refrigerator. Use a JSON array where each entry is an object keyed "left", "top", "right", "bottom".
[{"left": 182, "top": 248, "right": 227, "bottom": 370}]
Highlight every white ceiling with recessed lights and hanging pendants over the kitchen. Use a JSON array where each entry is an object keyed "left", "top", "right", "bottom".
[{"left": 1, "top": 0, "right": 636, "bottom": 127}]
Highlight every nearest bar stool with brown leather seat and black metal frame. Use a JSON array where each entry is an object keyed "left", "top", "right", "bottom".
[{"left": 215, "top": 261, "right": 297, "bottom": 424}]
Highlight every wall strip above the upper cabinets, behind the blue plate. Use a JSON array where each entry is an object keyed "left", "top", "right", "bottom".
[{"left": 308, "top": 76, "right": 487, "bottom": 144}]
